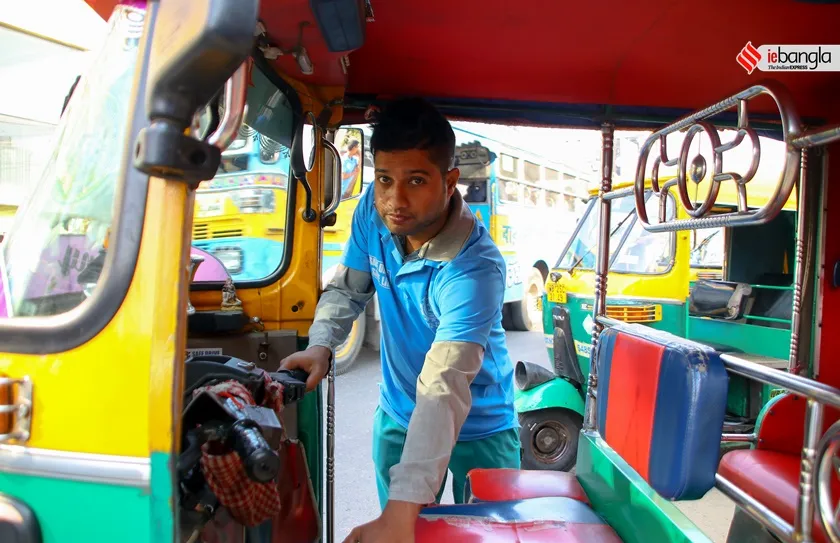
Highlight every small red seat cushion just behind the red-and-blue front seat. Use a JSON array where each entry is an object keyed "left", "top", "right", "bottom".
[{"left": 467, "top": 468, "right": 589, "bottom": 503}]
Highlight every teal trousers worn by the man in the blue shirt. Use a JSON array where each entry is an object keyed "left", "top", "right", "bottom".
[{"left": 373, "top": 407, "right": 520, "bottom": 509}]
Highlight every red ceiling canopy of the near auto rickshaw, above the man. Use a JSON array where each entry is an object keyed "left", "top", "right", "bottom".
[{"left": 86, "top": 0, "right": 840, "bottom": 129}]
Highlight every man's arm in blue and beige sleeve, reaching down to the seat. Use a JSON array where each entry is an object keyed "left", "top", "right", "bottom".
[{"left": 389, "top": 261, "right": 505, "bottom": 505}]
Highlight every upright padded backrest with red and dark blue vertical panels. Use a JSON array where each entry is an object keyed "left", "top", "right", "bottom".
[{"left": 597, "top": 323, "right": 729, "bottom": 500}]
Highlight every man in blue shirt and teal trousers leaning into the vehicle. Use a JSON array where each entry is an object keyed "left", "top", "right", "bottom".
[{"left": 282, "top": 99, "right": 520, "bottom": 543}]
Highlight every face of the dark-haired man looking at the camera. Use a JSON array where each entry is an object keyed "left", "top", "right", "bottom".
[{"left": 374, "top": 149, "right": 459, "bottom": 236}]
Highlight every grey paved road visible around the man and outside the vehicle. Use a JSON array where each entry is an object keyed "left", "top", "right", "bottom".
[{"left": 335, "top": 332, "right": 732, "bottom": 543}]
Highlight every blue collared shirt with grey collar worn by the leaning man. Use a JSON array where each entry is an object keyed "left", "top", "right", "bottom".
[{"left": 342, "top": 186, "right": 518, "bottom": 441}]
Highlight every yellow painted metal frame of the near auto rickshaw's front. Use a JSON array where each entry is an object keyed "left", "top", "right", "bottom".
[{"left": 0, "top": 66, "right": 343, "bottom": 457}]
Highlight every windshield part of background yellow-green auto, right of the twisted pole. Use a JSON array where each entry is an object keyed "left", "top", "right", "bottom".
[{"left": 610, "top": 195, "right": 675, "bottom": 274}]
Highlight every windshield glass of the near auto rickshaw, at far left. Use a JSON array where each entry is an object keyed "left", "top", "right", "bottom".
[{"left": 0, "top": 6, "right": 145, "bottom": 317}]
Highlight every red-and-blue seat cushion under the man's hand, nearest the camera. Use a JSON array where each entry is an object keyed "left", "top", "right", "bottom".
[{"left": 415, "top": 498, "right": 621, "bottom": 543}]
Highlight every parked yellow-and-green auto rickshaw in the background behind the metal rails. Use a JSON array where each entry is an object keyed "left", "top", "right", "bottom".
[{"left": 516, "top": 155, "right": 796, "bottom": 471}]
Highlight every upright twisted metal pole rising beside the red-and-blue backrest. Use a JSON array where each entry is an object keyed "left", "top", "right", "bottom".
[{"left": 583, "top": 123, "right": 615, "bottom": 431}]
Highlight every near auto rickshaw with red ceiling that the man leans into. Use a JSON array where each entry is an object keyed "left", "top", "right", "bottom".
[{"left": 0, "top": 0, "right": 840, "bottom": 543}]
